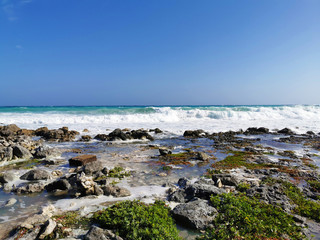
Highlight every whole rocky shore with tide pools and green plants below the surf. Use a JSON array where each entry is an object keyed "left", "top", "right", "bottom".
[{"left": 0, "top": 125, "right": 320, "bottom": 240}]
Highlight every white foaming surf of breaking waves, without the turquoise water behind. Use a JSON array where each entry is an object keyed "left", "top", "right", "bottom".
[{"left": 0, "top": 105, "right": 320, "bottom": 133}]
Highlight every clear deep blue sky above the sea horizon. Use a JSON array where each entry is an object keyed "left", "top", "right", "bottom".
[{"left": 0, "top": 0, "right": 320, "bottom": 106}]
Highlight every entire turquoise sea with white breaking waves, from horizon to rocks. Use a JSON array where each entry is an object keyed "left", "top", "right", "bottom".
[{"left": 0, "top": 105, "right": 320, "bottom": 134}]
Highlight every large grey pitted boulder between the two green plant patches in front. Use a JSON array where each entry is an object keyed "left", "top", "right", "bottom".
[{"left": 172, "top": 199, "right": 217, "bottom": 230}]
